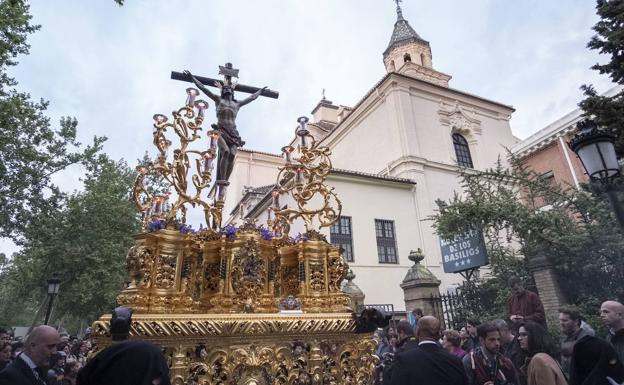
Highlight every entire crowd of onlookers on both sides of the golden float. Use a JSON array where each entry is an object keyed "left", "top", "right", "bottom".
[{"left": 0, "top": 279, "right": 624, "bottom": 385}]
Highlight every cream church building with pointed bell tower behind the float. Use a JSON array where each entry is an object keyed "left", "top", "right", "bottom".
[{"left": 224, "top": 7, "right": 518, "bottom": 310}]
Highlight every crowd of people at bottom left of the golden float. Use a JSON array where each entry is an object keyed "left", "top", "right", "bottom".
[{"left": 0, "top": 325, "right": 170, "bottom": 385}]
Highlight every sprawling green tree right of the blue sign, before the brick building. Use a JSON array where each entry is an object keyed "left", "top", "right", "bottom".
[{"left": 432, "top": 157, "right": 624, "bottom": 326}]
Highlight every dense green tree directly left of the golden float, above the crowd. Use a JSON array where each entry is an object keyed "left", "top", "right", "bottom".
[{"left": 0, "top": 155, "right": 140, "bottom": 327}]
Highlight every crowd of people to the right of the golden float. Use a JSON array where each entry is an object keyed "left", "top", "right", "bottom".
[{"left": 375, "top": 279, "right": 624, "bottom": 385}]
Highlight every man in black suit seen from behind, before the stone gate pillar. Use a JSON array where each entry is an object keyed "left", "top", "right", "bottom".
[{"left": 390, "top": 316, "right": 468, "bottom": 385}]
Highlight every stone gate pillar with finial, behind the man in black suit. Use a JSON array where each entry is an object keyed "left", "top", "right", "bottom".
[{"left": 401, "top": 249, "right": 441, "bottom": 315}]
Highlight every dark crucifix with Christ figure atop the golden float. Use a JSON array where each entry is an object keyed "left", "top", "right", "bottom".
[{"left": 171, "top": 63, "right": 279, "bottom": 185}]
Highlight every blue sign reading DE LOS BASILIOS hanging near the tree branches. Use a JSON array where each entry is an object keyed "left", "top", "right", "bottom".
[{"left": 440, "top": 229, "right": 489, "bottom": 273}]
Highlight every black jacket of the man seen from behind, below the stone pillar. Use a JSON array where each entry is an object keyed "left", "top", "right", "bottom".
[{"left": 390, "top": 344, "right": 468, "bottom": 385}]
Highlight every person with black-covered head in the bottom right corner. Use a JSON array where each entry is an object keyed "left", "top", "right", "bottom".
[{"left": 570, "top": 336, "right": 624, "bottom": 385}]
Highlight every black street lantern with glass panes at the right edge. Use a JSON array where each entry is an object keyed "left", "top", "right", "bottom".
[{"left": 568, "top": 119, "right": 624, "bottom": 228}]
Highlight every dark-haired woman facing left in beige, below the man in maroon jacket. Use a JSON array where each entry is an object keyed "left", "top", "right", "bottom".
[{"left": 518, "top": 321, "right": 568, "bottom": 385}]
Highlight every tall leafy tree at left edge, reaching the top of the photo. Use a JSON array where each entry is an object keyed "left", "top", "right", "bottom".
[{"left": 0, "top": 0, "right": 105, "bottom": 243}]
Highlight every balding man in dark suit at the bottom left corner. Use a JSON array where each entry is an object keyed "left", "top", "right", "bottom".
[{"left": 0, "top": 325, "right": 60, "bottom": 385}]
